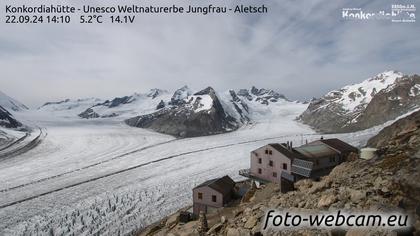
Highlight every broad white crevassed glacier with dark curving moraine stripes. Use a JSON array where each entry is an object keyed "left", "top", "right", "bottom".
[{"left": 0, "top": 109, "right": 377, "bottom": 235}]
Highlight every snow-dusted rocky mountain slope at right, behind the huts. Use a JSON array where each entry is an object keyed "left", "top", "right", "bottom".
[{"left": 299, "top": 71, "right": 420, "bottom": 133}]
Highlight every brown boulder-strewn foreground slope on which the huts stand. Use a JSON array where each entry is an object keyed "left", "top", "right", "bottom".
[{"left": 139, "top": 112, "right": 420, "bottom": 236}]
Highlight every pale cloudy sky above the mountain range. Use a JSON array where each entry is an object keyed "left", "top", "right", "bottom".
[{"left": 0, "top": 0, "right": 420, "bottom": 106}]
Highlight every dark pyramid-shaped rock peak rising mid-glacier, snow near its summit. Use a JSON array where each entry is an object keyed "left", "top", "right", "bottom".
[{"left": 125, "top": 87, "right": 238, "bottom": 137}]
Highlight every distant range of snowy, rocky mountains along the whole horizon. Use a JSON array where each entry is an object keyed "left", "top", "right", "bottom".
[{"left": 0, "top": 71, "right": 420, "bottom": 137}]
